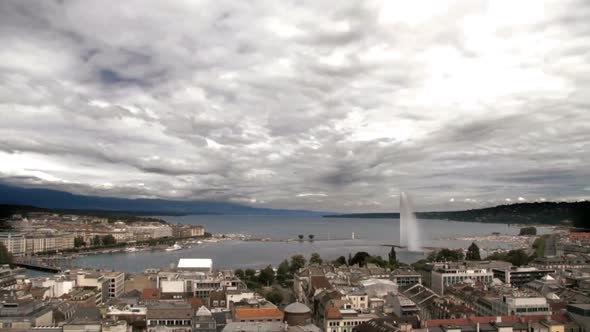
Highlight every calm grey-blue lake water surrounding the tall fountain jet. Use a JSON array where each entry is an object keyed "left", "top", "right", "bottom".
[{"left": 68, "top": 215, "right": 549, "bottom": 272}]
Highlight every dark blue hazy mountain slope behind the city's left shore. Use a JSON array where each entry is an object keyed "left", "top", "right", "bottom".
[{"left": 0, "top": 184, "right": 322, "bottom": 215}]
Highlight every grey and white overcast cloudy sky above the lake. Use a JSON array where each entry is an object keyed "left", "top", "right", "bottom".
[{"left": 0, "top": 0, "right": 590, "bottom": 212}]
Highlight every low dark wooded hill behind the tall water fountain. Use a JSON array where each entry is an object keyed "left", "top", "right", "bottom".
[{"left": 325, "top": 201, "right": 590, "bottom": 228}]
